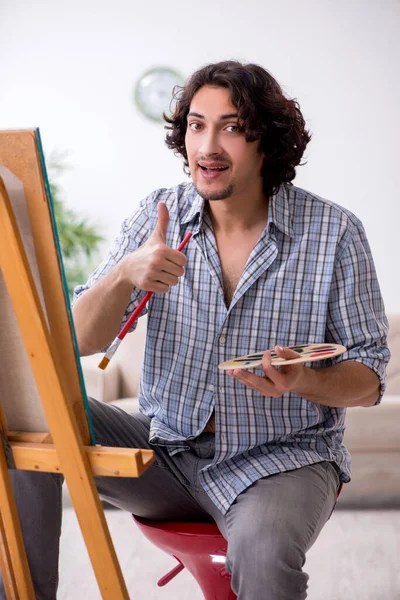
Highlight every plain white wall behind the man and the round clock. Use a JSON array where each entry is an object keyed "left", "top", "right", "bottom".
[{"left": 0, "top": 0, "right": 400, "bottom": 312}]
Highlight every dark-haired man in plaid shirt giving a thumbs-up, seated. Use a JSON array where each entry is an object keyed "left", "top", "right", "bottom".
[{"left": 2, "top": 61, "right": 389, "bottom": 600}]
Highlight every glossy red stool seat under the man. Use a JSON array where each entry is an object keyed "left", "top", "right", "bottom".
[{"left": 133, "top": 515, "right": 236, "bottom": 600}]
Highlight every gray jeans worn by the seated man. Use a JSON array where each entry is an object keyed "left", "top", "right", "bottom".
[{"left": 0, "top": 400, "right": 339, "bottom": 600}]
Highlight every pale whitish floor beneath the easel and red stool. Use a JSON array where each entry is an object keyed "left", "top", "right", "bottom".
[{"left": 58, "top": 490, "right": 400, "bottom": 600}]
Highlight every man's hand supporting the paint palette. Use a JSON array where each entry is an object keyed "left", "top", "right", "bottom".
[{"left": 227, "top": 346, "right": 307, "bottom": 398}]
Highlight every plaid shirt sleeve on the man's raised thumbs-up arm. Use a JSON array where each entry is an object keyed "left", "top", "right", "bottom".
[{"left": 72, "top": 192, "right": 157, "bottom": 338}]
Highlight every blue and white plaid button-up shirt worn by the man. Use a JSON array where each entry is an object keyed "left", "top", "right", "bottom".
[{"left": 75, "top": 183, "right": 390, "bottom": 513}]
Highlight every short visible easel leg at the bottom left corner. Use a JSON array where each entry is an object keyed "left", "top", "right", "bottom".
[{"left": 0, "top": 443, "right": 35, "bottom": 600}]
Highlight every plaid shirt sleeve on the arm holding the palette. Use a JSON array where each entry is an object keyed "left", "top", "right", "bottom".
[{"left": 324, "top": 222, "right": 390, "bottom": 404}]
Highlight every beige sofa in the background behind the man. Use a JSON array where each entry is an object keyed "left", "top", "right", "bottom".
[{"left": 81, "top": 314, "right": 400, "bottom": 508}]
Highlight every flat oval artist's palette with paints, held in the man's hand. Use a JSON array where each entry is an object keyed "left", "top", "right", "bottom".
[{"left": 218, "top": 344, "right": 346, "bottom": 371}]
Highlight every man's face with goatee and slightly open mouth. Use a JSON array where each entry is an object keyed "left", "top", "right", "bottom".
[{"left": 185, "top": 86, "right": 263, "bottom": 200}]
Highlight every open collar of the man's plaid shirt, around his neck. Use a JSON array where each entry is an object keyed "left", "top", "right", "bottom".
[{"left": 181, "top": 184, "right": 294, "bottom": 237}]
